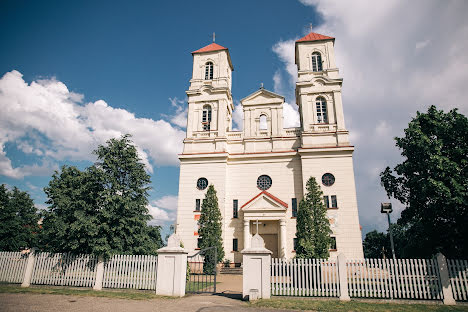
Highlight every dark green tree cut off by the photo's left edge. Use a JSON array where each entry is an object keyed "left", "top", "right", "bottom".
[{"left": 0, "top": 184, "right": 40, "bottom": 251}]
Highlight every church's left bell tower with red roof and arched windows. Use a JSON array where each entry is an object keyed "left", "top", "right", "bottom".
[{"left": 184, "top": 42, "right": 234, "bottom": 146}]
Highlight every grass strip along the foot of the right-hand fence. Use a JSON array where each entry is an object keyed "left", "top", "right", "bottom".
[{"left": 250, "top": 298, "right": 468, "bottom": 312}]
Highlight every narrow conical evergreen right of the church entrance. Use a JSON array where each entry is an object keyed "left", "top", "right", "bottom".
[{"left": 296, "top": 177, "right": 332, "bottom": 259}]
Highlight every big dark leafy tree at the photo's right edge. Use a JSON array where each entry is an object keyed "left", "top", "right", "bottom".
[{"left": 380, "top": 106, "right": 468, "bottom": 259}]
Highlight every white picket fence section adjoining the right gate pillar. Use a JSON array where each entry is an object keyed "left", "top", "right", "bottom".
[{"left": 270, "top": 258, "right": 339, "bottom": 297}]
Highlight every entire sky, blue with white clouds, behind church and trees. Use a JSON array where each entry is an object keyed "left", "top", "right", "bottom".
[{"left": 0, "top": 0, "right": 468, "bottom": 239}]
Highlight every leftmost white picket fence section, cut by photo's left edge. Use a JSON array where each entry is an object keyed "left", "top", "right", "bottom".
[{"left": 0, "top": 252, "right": 28, "bottom": 283}]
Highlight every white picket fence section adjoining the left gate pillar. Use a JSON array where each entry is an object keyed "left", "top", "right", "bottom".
[{"left": 102, "top": 255, "right": 158, "bottom": 290}]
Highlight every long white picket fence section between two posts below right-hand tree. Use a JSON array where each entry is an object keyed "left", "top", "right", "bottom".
[{"left": 347, "top": 259, "right": 443, "bottom": 300}]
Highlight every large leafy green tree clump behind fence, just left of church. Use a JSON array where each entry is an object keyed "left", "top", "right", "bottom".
[{"left": 43, "top": 135, "right": 162, "bottom": 258}]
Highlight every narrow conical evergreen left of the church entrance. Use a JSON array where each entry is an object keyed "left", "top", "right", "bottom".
[{"left": 198, "top": 185, "right": 224, "bottom": 274}]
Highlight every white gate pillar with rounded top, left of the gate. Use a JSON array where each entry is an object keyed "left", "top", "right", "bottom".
[{"left": 156, "top": 234, "right": 187, "bottom": 297}]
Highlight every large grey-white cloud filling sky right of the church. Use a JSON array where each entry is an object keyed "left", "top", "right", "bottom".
[{"left": 273, "top": 0, "right": 468, "bottom": 233}]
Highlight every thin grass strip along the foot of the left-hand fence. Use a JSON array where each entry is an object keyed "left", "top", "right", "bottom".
[{"left": 0, "top": 285, "right": 173, "bottom": 300}]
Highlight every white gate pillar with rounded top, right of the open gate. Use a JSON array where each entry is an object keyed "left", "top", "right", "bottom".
[{"left": 241, "top": 233, "right": 272, "bottom": 300}]
